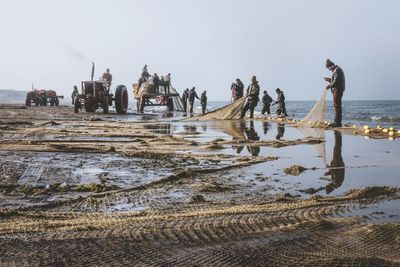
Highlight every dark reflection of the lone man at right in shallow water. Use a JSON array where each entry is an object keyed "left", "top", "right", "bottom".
[{"left": 325, "top": 131, "right": 345, "bottom": 194}]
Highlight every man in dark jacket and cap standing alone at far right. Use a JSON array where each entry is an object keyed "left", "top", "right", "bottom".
[{"left": 324, "top": 59, "right": 345, "bottom": 127}]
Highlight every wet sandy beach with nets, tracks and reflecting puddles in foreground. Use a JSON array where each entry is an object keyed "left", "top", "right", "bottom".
[{"left": 0, "top": 104, "right": 400, "bottom": 266}]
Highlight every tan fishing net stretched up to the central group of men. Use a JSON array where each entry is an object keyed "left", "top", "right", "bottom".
[{"left": 186, "top": 97, "right": 246, "bottom": 121}]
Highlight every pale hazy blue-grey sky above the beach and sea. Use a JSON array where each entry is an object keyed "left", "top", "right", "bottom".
[{"left": 0, "top": 0, "right": 400, "bottom": 101}]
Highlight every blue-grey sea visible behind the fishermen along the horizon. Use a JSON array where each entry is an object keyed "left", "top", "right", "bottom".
[{"left": 200, "top": 100, "right": 400, "bottom": 129}]
